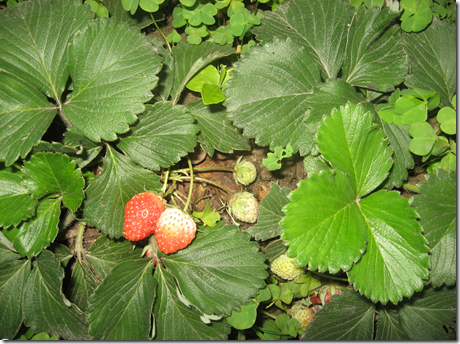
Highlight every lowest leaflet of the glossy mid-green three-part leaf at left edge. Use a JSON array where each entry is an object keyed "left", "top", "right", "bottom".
[{"left": 3, "top": 199, "right": 61, "bottom": 257}]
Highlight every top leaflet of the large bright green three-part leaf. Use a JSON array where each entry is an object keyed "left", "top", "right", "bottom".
[{"left": 317, "top": 103, "right": 392, "bottom": 197}]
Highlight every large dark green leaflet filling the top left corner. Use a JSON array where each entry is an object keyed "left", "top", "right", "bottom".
[{"left": 0, "top": 0, "right": 94, "bottom": 98}]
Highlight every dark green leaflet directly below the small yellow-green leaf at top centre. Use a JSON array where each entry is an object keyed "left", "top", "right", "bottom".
[{"left": 187, "top": 100, "right": 251, "bottom": 157}]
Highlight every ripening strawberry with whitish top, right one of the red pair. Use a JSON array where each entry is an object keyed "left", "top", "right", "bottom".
[{"left": 155, "top": 208, "right": 196, "bottom": 254}]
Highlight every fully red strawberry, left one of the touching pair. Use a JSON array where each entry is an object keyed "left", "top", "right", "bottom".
[{"left": 123, "top": 191, "right": 165, "bottom": 241}]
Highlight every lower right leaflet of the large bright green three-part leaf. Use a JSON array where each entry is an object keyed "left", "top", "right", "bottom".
[{"left": 347, "top": 190, "right": 430, "bottom": 304}]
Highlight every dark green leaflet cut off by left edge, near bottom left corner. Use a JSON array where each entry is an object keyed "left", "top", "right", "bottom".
[{"left": 0, "top": 253, "right": 30, "bottom": 339}]
